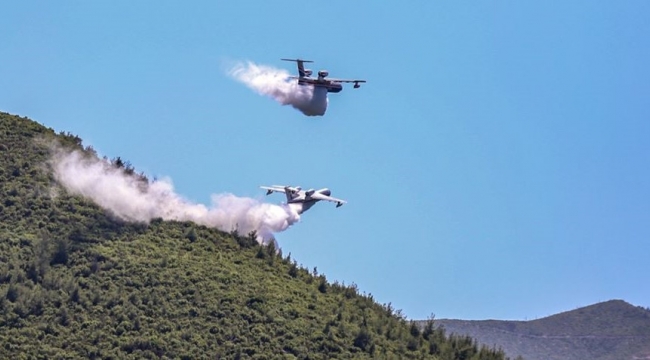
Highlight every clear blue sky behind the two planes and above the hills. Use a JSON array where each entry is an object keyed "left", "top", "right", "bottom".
[{"left": 0, "top": 1, "right": 650, "bottom": 320}]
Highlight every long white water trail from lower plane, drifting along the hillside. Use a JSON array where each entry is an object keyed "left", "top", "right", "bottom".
[{"left": 52, "top": 150, "right": 300, "bottom": 243}]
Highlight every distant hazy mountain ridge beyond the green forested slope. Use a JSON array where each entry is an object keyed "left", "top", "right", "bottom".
[{"left": 420, "top": 300, "right": 650, "bottom": 360}]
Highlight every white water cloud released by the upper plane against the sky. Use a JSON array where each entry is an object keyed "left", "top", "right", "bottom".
[{"left": 229, "top": 62, "right": 328, "bottom": 116}]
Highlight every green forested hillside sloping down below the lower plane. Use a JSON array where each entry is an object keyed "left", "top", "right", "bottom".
[{"left": 0, "top": 113, "right": 505, "bottom": 359}]
